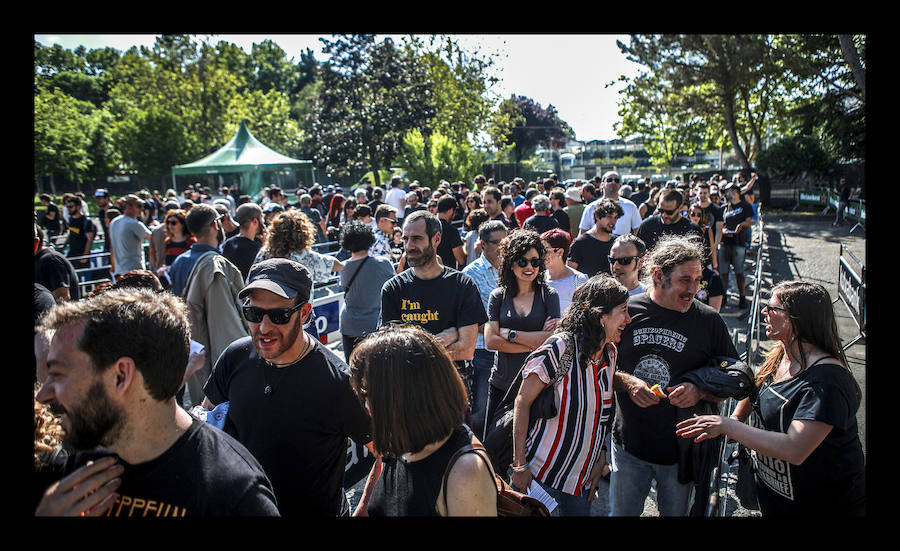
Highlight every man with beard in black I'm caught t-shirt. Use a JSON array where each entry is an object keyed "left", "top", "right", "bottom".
[{"left": 379, "top": 211, "right": 488, "bottom": 414}]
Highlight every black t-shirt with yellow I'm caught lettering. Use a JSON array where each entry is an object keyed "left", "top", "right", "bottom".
[{"left": 379, "top": 266, "right": 487, "bottom": 335}]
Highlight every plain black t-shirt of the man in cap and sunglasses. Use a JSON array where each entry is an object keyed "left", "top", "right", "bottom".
[{"left": 203, "top": 337, "right": 371, "bottom": 517}]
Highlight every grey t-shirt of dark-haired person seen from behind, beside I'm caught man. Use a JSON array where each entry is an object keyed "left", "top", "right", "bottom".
[{"left": 341, "top": 256, "right": 394, "bottom": 337}]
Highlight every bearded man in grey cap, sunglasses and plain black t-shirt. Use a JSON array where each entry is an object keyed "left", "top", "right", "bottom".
[{"left": 203, "top": 258, "right": 372, "bottom": 517}]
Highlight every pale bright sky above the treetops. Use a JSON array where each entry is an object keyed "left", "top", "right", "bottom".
[{"left": 34, "top": 34, "right": 638, "bottom": 141}]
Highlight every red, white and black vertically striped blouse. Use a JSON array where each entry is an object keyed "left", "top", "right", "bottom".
[{"left": 522, "top": 335, "right": 616, "bottom": 496}]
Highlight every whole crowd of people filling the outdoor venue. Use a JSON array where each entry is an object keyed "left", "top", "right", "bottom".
[{"left": 34, "top": 171, "right": 865, "bottom": 517}]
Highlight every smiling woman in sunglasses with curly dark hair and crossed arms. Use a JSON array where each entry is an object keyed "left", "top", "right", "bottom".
[{"left": 484, "top": 230, "right": 560, "bottom": 440}]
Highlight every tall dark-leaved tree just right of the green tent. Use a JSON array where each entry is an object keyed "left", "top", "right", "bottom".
[{"left": 310, "top": 35, "right": 435, "bottom": 190}]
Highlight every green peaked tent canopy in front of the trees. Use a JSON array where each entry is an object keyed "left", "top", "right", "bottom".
[{"left": 172, "top": 122, "right": 313, "bottom": 196}]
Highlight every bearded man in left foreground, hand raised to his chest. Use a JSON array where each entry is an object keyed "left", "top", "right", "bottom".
[{"left": 35, "top": 289, "right": 278, "bottom": 517}]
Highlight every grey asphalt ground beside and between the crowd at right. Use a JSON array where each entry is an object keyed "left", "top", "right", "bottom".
[{"left": 332, "top": 212, "right": 866, "bottom": 517}]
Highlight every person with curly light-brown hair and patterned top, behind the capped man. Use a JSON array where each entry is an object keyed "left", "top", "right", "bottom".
[{"left": 254, "top": 209, "right": 344, "bottom": 288}]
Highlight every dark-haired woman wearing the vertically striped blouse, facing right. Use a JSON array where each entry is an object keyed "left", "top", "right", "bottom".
[{"left": 512, "top": 273, "right": 631, "bottom": 516}]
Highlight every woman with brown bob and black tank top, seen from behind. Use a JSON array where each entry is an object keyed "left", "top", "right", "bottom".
[{"left": 349, "top": 327, "right": 497, "bottom": 516}]
